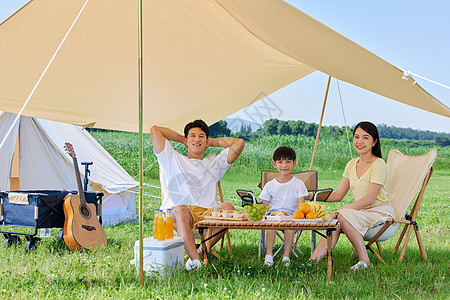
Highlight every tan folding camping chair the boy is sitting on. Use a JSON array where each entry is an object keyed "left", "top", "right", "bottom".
[{"left": 258, "top": 170, "right": 318, "bottom": 257}]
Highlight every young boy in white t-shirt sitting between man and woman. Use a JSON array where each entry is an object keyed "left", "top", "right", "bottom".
[{"left": 259, "top": 146, "right": 309, "bottom": 267}]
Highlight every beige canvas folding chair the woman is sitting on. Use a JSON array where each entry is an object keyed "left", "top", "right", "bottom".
[{"left": 352, "top": 149, "right": 437, "bottom": 262}]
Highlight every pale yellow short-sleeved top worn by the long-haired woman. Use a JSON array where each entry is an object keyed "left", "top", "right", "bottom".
[{"left": 342, "top": 157, "right": 388, "bottom": 208}]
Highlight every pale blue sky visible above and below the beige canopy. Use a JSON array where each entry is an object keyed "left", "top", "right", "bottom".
[{"left": 0, "top": 0, "right": 450, "bottom": 133}]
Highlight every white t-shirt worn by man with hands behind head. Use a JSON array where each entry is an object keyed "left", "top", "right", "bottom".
[{"left": 153, "top": 140, "right": 231, "bottom": 209}]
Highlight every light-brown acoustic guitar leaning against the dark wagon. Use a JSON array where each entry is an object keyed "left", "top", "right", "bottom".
[{"left": 63, "top": 143, "right": 106, "bottom": 250}]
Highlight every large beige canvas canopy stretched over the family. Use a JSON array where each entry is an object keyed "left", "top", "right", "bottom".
[{"left": 0, "top": 0, "right": 450, "bottom": 132}]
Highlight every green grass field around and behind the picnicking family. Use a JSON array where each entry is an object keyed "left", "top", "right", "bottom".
[{"left": 0, "top": 132, "right": 450, "bottom": 299}]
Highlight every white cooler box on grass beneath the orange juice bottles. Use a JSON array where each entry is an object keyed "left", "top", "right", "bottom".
[{"left": 131, "top": 237, "right": 184, "bottom": 276}]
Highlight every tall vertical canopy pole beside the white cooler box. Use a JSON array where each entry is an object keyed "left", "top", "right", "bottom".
[{"left": 138, "top": 0, "right": 144, "bottom": 288}]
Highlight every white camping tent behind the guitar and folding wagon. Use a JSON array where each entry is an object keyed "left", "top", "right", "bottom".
[{"left": 0, "top": 112, "right": 137, "bottom": 225}]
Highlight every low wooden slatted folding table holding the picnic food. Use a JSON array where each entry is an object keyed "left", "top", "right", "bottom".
[{"left": 194, "top": 219, "right": 339, "bottom": 277}]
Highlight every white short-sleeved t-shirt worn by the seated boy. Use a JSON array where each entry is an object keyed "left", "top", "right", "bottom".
[{"left": 259, "top": 177, "right": 308, "bottom": 211}]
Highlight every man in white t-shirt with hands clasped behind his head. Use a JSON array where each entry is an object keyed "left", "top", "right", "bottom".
[{"left": 150, "top": 120, "right": 245, "bottom": 270}]
